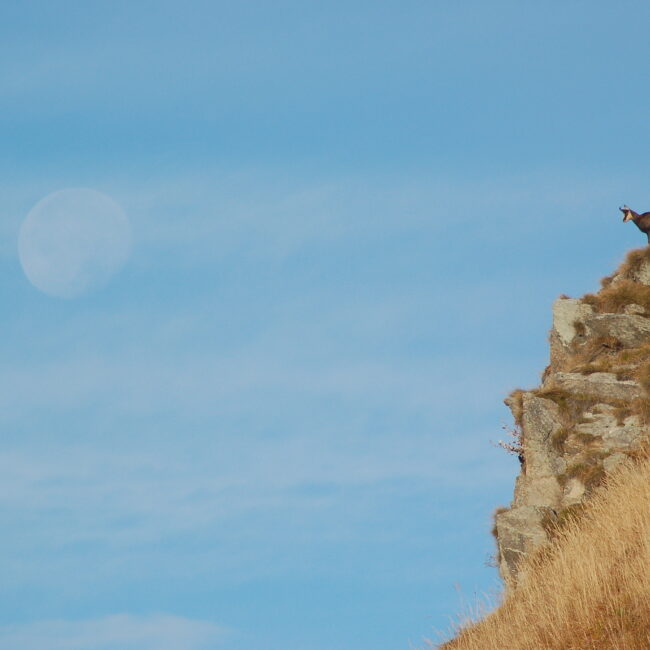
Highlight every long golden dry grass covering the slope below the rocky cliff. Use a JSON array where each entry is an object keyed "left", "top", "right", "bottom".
[{"left": 432, "top": 457, "right": 650, "bottom": 650}]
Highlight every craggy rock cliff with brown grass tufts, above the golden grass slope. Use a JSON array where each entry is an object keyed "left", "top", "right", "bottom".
[{"left": 494, "top": 247, "right": 650, "bottom": 586}]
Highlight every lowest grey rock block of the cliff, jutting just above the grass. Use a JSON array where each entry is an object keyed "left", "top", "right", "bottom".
[{"left": 494, "top": 506, "right": 555, "bottom": 585}]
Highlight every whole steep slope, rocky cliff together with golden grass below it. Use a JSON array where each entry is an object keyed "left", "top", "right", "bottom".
[{"left": 442, "top": 247, "right": 650, "bottom": 650}]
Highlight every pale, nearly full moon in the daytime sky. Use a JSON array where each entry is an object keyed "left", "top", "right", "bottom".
[{"left": 18, "top": 188, "right": 131, "bottom": 298}]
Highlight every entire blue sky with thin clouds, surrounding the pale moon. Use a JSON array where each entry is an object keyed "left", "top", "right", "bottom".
[{"left": 0, "top": 0, "right": 650, "bottom": 650}]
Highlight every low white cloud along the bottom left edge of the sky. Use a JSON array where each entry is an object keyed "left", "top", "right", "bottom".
[{"left": 0, "top": 614, "right": 224, "bottom": 650}]
